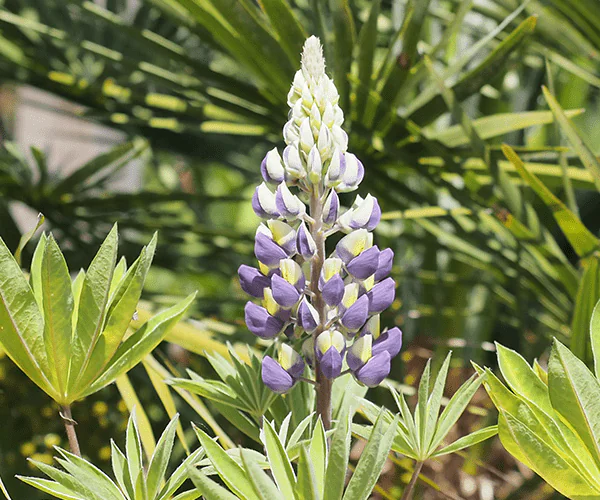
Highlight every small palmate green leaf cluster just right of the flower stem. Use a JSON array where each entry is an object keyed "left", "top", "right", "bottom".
[{"left": 353, "top": 354, "right": 497, "bottom": 462}]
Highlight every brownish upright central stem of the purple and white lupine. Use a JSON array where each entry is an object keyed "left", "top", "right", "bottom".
[{"left": 310, "top": 188, "right": 333, "bottom": 430}]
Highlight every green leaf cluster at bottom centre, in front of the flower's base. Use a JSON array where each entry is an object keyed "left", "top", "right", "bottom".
[{"left": 189, "top": 414, "right": 397, "bottom": 500}]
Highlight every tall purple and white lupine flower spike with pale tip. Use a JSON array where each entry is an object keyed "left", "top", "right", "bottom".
[{"left": 239, "top": 37, "right": 402, "bottom": 392}]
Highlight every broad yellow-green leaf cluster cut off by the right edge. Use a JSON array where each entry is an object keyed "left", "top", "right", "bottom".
[{"left": 479, "top": 306, "right": 600, "bottom": 499}]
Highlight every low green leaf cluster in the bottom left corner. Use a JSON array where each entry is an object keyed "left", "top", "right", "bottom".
[{"left": 20, "top": 414, "right": 204, "bottom": 500}]
